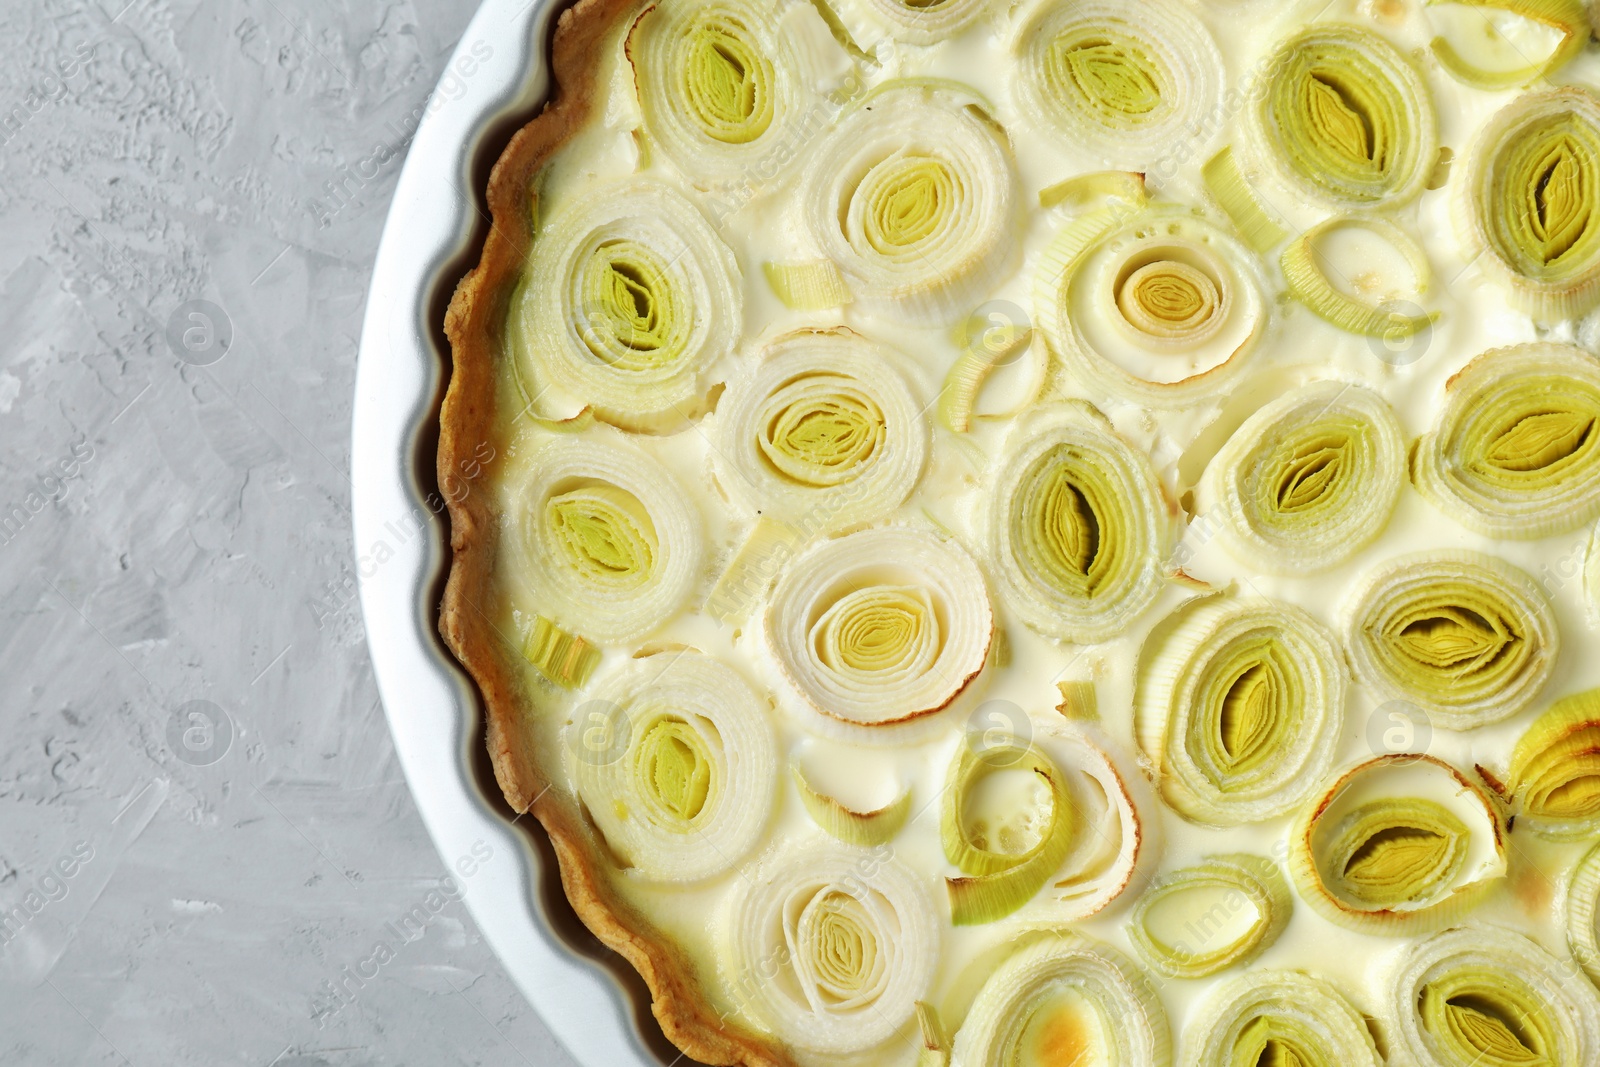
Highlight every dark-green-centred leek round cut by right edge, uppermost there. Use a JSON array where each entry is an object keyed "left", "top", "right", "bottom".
[{"left": 1456, "top": 88, "right": 1600, "bottom": 323}]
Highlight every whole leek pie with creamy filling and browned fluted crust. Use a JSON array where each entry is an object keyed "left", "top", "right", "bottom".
[{"left": 438, "top": 0, "right": 1600, "bottom": 1067}]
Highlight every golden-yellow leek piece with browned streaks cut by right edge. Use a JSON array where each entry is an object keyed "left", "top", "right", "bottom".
[{"left": 1506, "top": 689, "right": 1600, "bottom": 841}]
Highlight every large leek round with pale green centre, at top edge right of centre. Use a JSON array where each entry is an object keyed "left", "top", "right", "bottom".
[{"left": 1014, "top": 0, "right": 1222, "bottom": 171}]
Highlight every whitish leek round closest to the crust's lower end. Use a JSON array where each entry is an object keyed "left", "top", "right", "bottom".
[{"left": 720, "top": 845, "right": 939, "bottom": 1054}]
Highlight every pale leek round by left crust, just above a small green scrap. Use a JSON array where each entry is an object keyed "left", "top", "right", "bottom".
[{"left": 520, "top": 437, "right": 704, "bottom": 643}]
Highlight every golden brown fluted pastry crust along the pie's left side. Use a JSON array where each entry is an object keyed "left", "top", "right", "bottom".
[{"left": 438, "top": 0, "right": 794, "bottom": 1067}]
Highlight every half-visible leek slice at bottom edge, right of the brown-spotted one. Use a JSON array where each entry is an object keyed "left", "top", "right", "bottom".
[{"left": 1181, "top": 971, "right": 1384, "bottom": 1067}]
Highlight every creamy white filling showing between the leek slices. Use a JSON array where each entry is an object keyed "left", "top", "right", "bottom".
[{"left": 490, "top": 0, "right": 1600, "bottom": 1064}]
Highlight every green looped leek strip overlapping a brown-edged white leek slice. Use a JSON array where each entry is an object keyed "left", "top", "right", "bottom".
[{"left": 939, "top": 736, "right": 1077, "bottom": 926}]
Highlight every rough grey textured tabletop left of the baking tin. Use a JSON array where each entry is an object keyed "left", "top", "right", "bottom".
[{"left": 0, "top": 0, "right": 571, "bottom": 1067}]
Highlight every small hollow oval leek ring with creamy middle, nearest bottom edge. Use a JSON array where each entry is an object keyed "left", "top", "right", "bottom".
[{"left": 1128, "top": 856, "right": 1294, "bottom": 979}]
